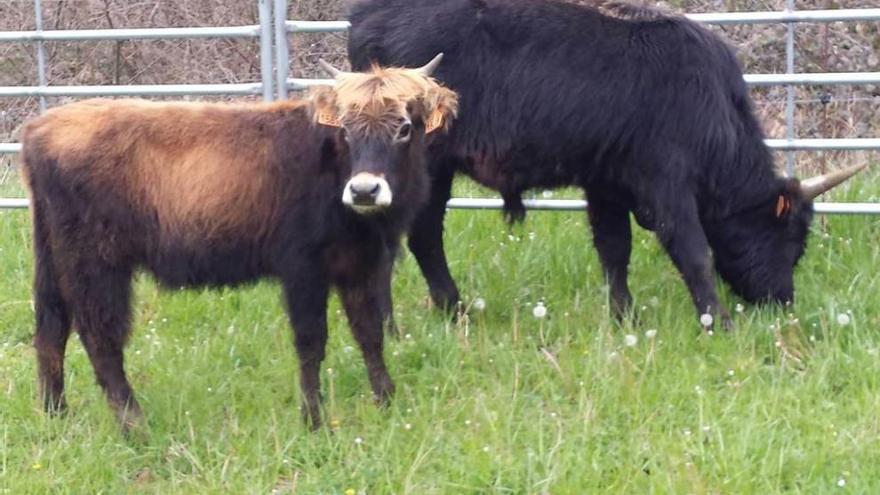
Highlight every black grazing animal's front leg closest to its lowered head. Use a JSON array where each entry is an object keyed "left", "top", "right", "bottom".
[{"left": 655, "top": 198, "right": 732, "bottom": 329}]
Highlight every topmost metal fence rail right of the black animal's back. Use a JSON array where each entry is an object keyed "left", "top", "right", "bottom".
[{"left": 685, "top": 9, "right": 880, "bottom": 25}]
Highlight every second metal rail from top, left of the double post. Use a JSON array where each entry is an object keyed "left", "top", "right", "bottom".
[{"left": 0, "top": 83, "right": 263, "bottom": 97}]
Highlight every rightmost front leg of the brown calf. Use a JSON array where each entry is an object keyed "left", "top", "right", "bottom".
[{"left": 339, "top": 268, "right": 394, "bottom": 405}]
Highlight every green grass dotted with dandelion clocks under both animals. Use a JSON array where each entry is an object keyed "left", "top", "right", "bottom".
[{"left": 0, "top": 171, "right": 880, "bottom": 494}]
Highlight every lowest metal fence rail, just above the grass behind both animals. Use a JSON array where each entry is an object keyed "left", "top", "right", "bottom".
[{"left": 0, "top": 198, "right": 880, "bottom": 215}]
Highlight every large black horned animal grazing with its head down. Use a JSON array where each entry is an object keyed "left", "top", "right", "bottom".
[{"left": 349, "top": 0, "right": 857, "bottom": 325}]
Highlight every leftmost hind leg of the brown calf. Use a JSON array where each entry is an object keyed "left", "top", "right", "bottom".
[{"left": 33, "top": 200, "right": 71, "bottom": 412}]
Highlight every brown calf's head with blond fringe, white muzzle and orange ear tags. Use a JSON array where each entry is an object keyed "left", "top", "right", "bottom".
[{"left": 311, "top": 54, "right": 458, "bottom": 214}]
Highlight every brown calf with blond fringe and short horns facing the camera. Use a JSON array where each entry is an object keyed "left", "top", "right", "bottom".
[{"left": 22, "top": 58, "right": 457, "bottom": 429}]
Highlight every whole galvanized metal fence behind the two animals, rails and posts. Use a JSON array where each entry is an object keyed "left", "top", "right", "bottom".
[{"left": 0, "top": 0, "right": 880, "bottom": 215}]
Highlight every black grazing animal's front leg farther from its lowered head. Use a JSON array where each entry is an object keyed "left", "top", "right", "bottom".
[{"left": 587, "top": 189, "right": 632, "bottom": 319}]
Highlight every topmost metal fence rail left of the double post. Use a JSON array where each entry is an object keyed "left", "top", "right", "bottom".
[{"left": 0, "top": 25, "right": 260, "bottom": 42}]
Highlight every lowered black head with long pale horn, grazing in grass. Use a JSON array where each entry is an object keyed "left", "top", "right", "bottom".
[{"left": 705, "top": 165, "right": 864, "bottom": 303}]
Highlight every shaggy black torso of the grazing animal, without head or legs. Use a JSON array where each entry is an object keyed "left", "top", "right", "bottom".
[{"left": 349, "top": 0, "right": 753, "bottom": 197}]
